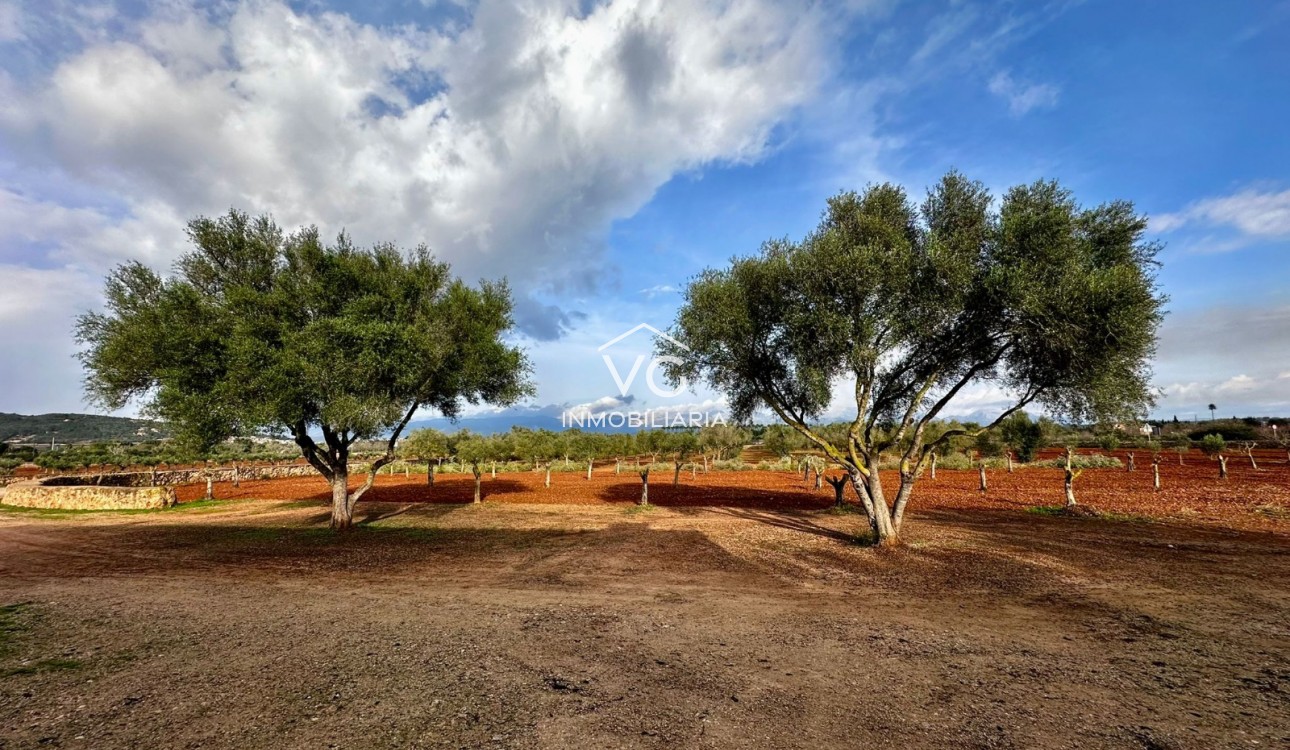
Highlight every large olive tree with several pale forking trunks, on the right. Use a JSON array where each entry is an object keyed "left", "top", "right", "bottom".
[{"left": 658, "top": 172, "right": 1165, "bottom": 545}]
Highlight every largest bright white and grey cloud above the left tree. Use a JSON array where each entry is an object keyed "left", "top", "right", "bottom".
[{"left": 0, "top": 0, "right": 827, "bottom": 338}]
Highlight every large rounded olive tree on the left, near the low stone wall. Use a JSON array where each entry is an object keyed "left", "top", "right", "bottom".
[{"left": 77, "top": 212, "right": 530, "bottom": 529}]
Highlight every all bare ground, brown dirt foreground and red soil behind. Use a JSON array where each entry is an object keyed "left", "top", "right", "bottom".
[{"left": 0, "top": 457, "right": 1290, "bottom": 749}]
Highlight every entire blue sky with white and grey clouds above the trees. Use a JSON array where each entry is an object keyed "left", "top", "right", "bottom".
[{"left": 0, "top": 0, "right": 1290, "bottom": 418}]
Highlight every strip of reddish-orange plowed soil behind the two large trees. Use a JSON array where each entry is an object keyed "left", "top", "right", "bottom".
[{"left": 178, "top": 451, "right": 1290, "bottom": 531}]
